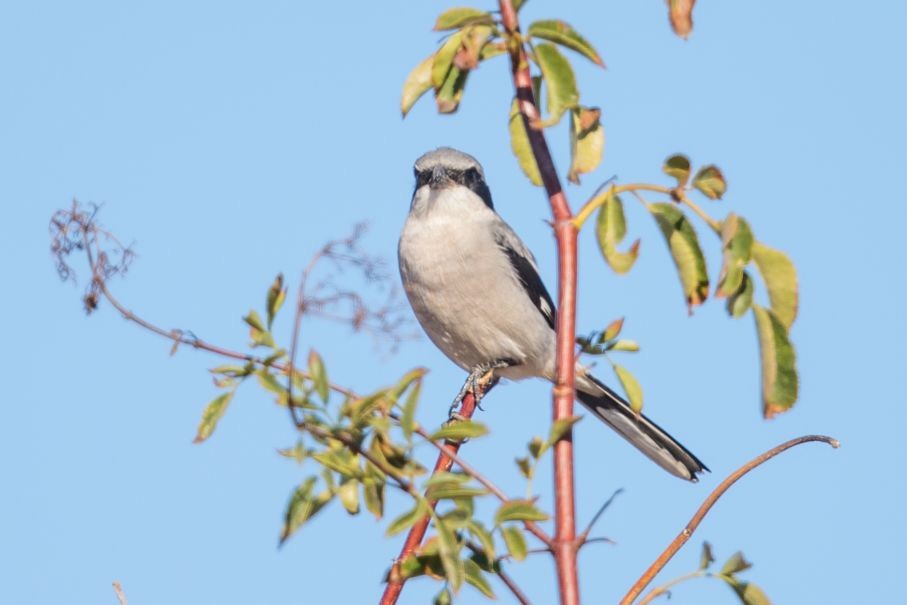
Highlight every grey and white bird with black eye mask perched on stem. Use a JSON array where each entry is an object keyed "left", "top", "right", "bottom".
[{"left": 397, "top": 147, "right": 708, "bottom": 482}]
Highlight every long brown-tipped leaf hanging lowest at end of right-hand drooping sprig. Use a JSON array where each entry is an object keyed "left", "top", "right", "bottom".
[{"left": 753, "top": 305, "right": 798, "bottom": 418}]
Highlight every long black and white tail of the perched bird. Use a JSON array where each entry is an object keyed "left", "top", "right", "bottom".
[{"left": 576, "top": 374, "right": 709, "bottom": 482}]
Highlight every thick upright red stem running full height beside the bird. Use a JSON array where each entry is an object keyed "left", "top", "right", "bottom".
[{"left": 498, "top": 0, "right": 579, "bottom": 605}]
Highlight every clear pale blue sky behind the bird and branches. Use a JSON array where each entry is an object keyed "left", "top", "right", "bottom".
[{"left": 0, "top": 0, "right": 907, "bottom": 605}]
